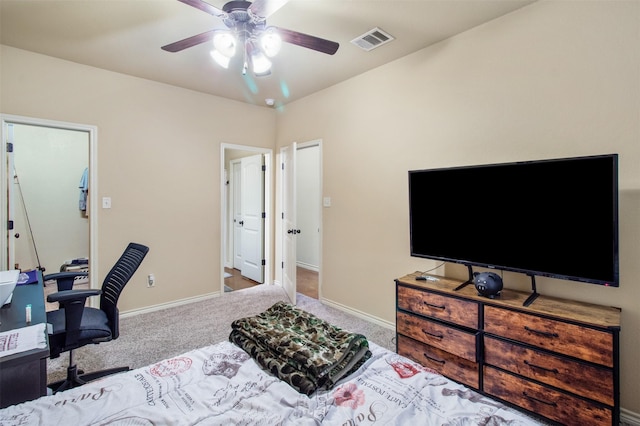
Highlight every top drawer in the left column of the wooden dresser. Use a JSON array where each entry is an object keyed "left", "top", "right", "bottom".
[{"left": 398, "top": 286, "right": 479, "bottom": 329}]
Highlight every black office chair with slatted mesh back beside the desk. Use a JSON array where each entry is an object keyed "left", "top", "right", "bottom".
[{"left": 47, "top": 243, "right": 149, "bottom": 393}]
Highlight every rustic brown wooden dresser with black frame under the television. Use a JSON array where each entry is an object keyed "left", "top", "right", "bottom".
[{"left": 396, "top": 273, "right": 620, "bottom": 425}]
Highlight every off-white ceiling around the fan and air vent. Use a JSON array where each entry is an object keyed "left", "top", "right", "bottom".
[{"left": 0, "top": 0, "right": 536, "bottom": 106}]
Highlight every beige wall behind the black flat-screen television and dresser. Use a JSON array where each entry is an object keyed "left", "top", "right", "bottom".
[{"left": 278, "top": 1, "right": 640, "bottom": 413}]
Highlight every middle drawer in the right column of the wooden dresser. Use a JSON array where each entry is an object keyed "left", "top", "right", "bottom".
[{"left": 484, "top": 336, "right": 614, "bottom": 405}]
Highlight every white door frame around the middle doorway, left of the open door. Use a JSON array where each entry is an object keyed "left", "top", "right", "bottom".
[{"left": 220, "top": 142, "right": 273, "bottom": 294}]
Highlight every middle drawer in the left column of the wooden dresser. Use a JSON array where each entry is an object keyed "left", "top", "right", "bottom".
[{"left": 396, "top": 312, "right": 478, "bottom": 362}]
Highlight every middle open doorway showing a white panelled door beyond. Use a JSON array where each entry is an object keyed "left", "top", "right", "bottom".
[{"left": 221, "top": 144, "right": 272, "bottom": 292}]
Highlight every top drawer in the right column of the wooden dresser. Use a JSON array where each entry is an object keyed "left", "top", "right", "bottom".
[{"left": 484, "top": 306, "right": 614, "bottom": 367}]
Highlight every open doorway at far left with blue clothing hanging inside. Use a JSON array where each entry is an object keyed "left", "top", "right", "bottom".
[{"left": 0, "top": 115, "right": 98, "bottom": 292}]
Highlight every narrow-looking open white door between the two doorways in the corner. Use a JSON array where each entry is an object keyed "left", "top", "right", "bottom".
[{"left": 280, "top": 142, "right": 298, "bottom": 304}]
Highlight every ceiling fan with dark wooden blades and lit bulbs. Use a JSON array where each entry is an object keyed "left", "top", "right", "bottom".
[{"left": 162, "top": 0, "right": 340, "bottom": 76}]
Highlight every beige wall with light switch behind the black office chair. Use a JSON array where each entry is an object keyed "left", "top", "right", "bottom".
[{"left": 0, "top": 46, "right": 275, "bottom": 311}]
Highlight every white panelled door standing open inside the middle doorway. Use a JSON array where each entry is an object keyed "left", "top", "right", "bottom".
[{"left": 240, "top": 154, "right": 265, "bottom": 283}]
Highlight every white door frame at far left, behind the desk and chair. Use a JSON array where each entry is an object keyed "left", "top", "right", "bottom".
[{"left": 0, "top": 114, "right": 99, "bottom": 288}]
